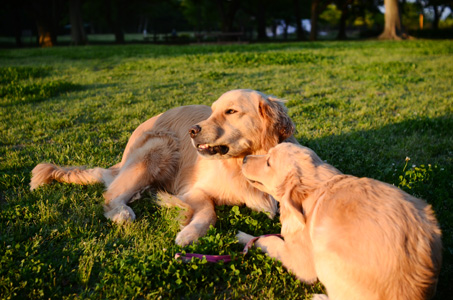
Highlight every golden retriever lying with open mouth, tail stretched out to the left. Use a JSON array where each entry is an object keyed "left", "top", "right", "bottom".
[{"left": 30, "top": 90, "right": 297, "bottom": 246}]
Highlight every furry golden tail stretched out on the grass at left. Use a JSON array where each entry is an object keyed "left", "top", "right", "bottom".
[{"left": 30, "top": 163, "right": 118, "bottom": 190}]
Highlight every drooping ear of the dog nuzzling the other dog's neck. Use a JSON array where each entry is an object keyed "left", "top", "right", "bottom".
[{"left": 278, "top": 174, "right": 306, "bottom": 234}]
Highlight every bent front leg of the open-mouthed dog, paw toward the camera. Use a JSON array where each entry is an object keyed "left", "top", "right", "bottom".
[{"left": 176, "top": 191, "right": 217, "bottom": 246}]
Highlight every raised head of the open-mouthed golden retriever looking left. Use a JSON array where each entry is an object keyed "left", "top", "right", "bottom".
[{"left": 189, "top": 90, "right": 294, "bottom": 159}]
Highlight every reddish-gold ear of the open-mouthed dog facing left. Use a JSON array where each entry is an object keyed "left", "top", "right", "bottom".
[{"left": 259, "top": 97, "right": 295, "bottom": 150}]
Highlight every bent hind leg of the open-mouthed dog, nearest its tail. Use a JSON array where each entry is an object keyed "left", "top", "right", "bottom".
[{"left": 104, "top": 131, "right": 180, "bottom": 223}]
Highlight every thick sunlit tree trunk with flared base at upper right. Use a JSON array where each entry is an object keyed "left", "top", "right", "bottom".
[{"left": 378, "top": 0, "right": 407, "bottom": 40}]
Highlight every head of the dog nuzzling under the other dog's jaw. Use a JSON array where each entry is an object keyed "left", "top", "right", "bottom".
[{"left": 242, "top": 143, "right": 339, "bottom": 230}]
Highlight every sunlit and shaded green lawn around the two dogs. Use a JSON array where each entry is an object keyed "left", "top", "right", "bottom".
[{"left": 0, "top": 40, "right": 453, "bottom": 299}]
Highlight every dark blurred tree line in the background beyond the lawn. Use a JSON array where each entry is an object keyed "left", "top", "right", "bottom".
[{"left": 0, "top": 0, "right": 453, "bottom": 47}]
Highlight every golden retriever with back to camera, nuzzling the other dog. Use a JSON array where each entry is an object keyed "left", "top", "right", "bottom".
[{"left": 238, "top": 143, "right": 442, "bottom": 300}]
